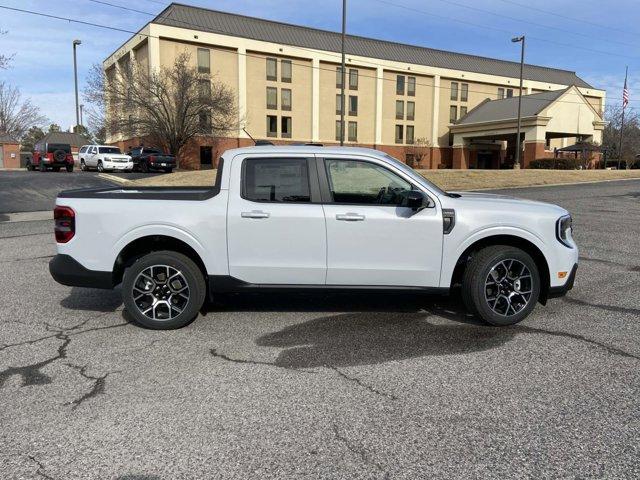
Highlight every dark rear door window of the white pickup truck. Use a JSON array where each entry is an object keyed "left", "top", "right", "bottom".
[{"left": 242, "top": 158, "right": 311, "bottom": 202}]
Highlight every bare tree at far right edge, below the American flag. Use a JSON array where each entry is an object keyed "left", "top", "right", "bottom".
[{"left": 602, "top": 105, "right": 640, "bottom": 167}]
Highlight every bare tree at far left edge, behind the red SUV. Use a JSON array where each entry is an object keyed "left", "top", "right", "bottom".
[{"left": 0, "top": 81, "right": 46, "bottom": 139}]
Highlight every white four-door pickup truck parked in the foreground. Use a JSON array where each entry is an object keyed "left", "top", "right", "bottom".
[{"left": 50, "top": 146, "right": 578, "bottom": 329}]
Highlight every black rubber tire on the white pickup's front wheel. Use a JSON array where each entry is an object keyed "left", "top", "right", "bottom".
[{"left": 462, "top": 245, "right": 540, "bottom": 326}]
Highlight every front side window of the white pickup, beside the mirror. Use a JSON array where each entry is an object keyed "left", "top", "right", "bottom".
[{"left": 325, "top": 159, "right": 412, "bottom": 206}]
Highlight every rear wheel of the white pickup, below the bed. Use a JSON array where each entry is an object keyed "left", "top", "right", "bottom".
[{"left": 122, "top": 251, "right": 206, "bottom": 330}]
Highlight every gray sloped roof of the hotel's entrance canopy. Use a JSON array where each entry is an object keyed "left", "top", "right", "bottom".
[{"left": 456, "top": 87, "right": 571, "bottom": 125}]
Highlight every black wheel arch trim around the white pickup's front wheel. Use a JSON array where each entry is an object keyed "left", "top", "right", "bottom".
[{"left": 450, "top": 234, "right": 550, "bottom": 305}]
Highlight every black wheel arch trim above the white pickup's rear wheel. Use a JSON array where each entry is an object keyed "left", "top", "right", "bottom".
[{"left": 112, "top": 234, "right": 208, "bottom": 285}]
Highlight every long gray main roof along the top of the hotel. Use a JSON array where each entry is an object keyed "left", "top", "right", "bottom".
[{"left": 152, "top": 3, "right": 593, "bottom": 88}]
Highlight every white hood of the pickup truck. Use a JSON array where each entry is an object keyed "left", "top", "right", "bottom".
[{"left": 443, "top": 192, "right": 568, "bottom": 217}]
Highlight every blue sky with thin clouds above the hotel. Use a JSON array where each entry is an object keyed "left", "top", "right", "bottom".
[{"left": 0, "top": 0, "right": 640, "bottom": 129}]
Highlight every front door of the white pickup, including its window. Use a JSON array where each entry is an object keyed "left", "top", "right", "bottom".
[{"left": 318, "top": 157, "right": 443, "bottom": 287}]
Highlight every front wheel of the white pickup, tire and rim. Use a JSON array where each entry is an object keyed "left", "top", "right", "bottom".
[{"left": 462, "top": 245, "right": 540, "bottom": 326}]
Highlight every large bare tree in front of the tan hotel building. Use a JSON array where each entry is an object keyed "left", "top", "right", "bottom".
[{"left": 85, "top": 54, "right": 239, "bottom": 166}]
